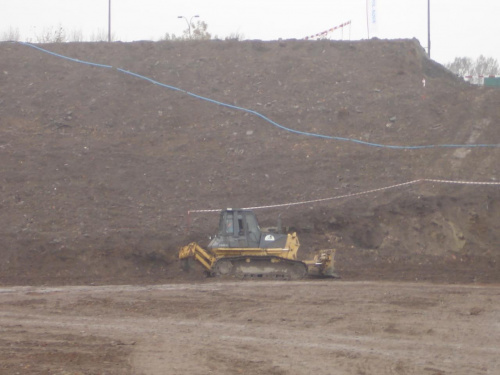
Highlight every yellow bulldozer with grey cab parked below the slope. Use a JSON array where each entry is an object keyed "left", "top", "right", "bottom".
[{"left": 179, "top": 208, "right": 338, "bottom": 280}]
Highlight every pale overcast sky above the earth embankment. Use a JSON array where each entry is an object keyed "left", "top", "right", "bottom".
[{"left": 0, "top": 0, "right": 500, "bottom": 63}]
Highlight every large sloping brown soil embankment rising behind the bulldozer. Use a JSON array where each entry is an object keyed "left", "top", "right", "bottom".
[{"left": 0, "top": 39, "right": 500, "bottom": 284}]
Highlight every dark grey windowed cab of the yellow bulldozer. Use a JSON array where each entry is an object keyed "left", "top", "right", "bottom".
[{"left": 217, "top": 209, "right": 261, "bottom": 248}]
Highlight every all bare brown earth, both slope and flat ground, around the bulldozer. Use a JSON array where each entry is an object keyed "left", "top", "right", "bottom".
[{"left": 0, "top": 39, "right": 500, "bottom": 375}]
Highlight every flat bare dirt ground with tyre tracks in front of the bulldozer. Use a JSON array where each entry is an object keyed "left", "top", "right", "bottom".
[{"left": 0, "top": 280, "right": 500, "bottom": 375}]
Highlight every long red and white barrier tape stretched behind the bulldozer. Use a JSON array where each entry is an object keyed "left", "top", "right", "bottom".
[{"left": 188, "top": 178, "right": 500, "bottom": 216}]
